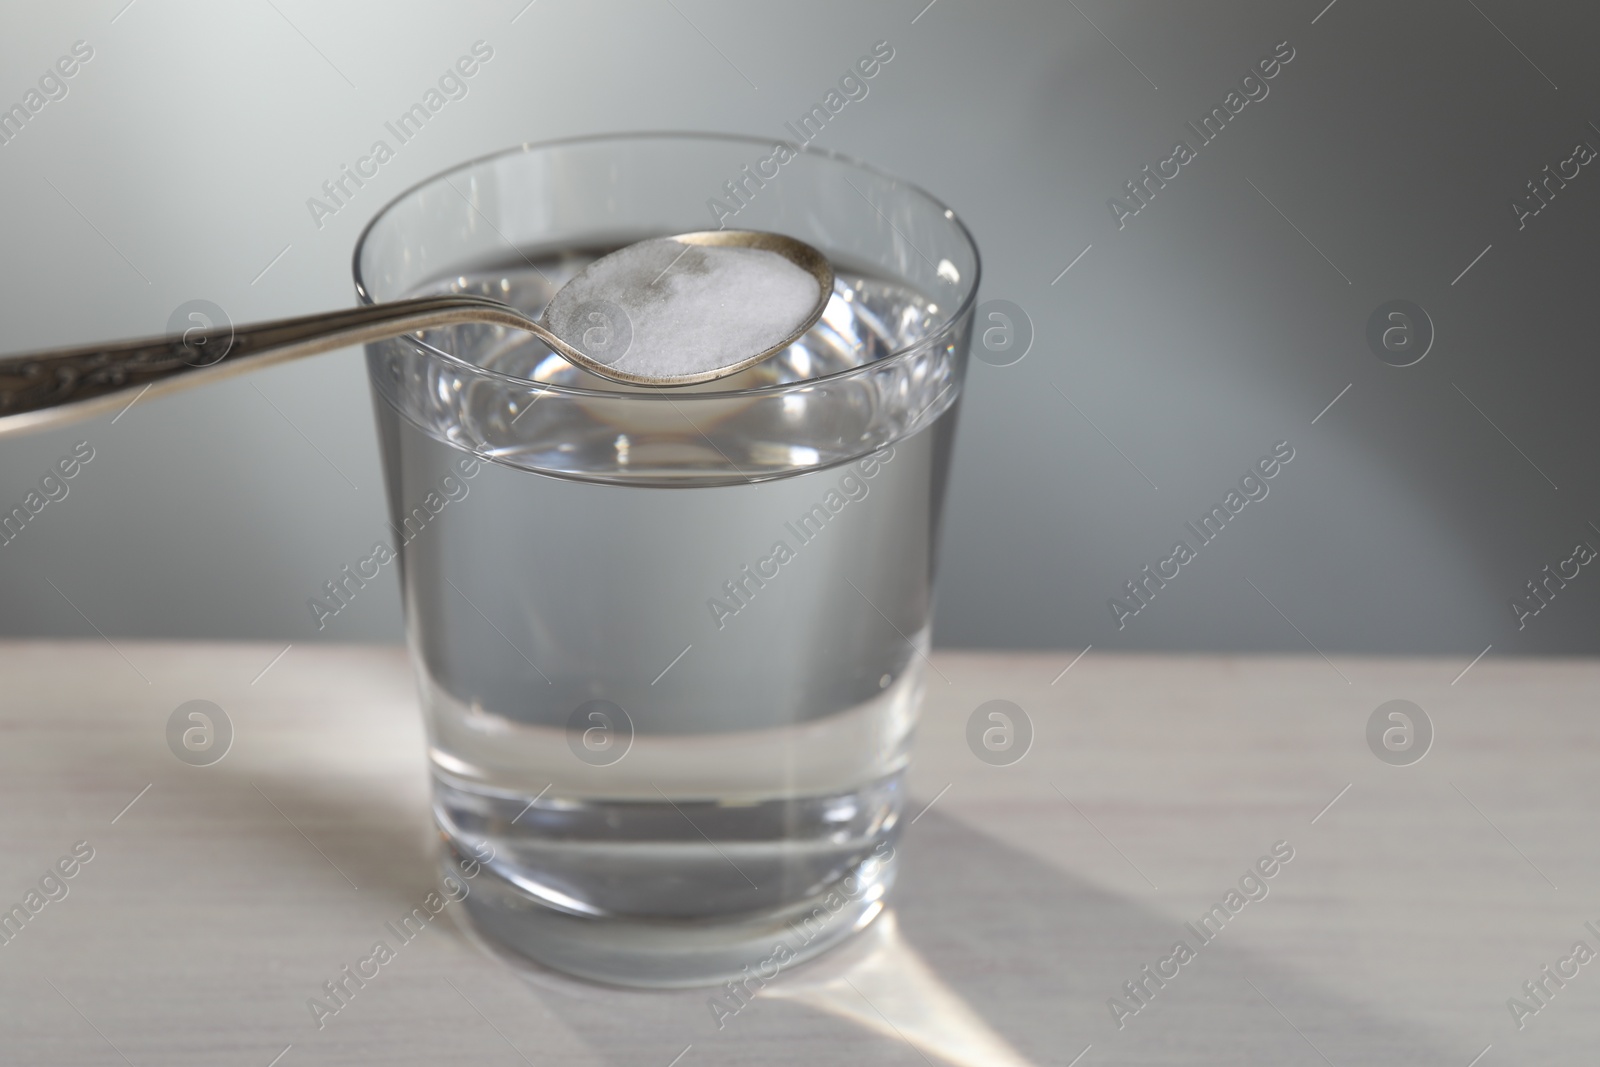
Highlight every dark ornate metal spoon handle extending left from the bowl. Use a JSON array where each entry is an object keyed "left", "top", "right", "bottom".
[{"left": 0, "top": 296, "right": 547, "bottom": 437}]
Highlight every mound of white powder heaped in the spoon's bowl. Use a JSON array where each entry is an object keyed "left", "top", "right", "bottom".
[{"left": 544, "top": 237, "right": 818, "bottom": 381}]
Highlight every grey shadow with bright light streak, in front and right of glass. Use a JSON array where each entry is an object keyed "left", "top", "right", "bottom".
[{"left": 438, "top": 813, "right": 1474, "bottom": 1067}]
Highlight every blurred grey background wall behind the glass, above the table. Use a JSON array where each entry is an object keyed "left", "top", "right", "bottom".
[{"left": 0, "top": 0, "right": 1600, "bottom": 662}]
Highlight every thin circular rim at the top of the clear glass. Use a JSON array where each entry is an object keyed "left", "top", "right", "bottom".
[{"left": 350, "top": 130, "right": 982, "bottom": 402}]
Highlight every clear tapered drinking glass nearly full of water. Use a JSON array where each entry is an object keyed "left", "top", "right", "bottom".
[{"left": 355, "top": 134, "right": 979, "bottom": 985}]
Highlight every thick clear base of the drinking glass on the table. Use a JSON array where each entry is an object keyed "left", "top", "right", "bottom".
[{"left": 443, "top": 838, "right": 896, "bottom": 993}]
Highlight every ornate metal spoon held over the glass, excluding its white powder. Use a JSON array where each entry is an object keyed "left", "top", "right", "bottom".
[{"left": 0, "top": 230, "right": 834, "bottom": 437}]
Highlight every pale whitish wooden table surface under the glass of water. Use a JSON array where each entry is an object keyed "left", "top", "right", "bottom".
[{"left": 0, "top": 641, "right": 1600, "bottom": 1067}]
